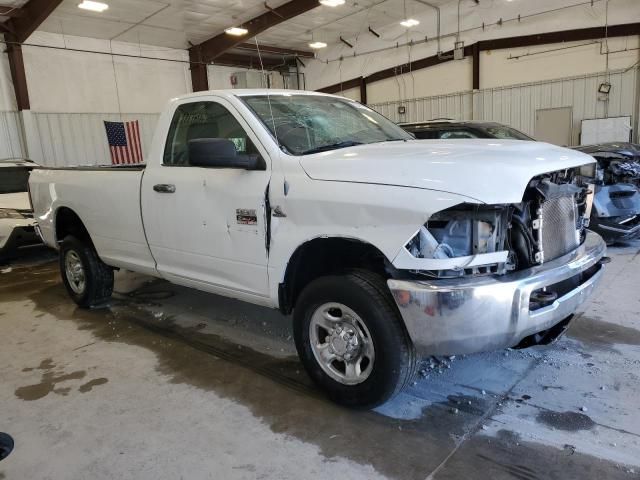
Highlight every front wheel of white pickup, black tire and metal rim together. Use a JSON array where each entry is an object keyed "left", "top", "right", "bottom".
[{"left": 294, "top": 270, "right": 417, "bottom": 409}]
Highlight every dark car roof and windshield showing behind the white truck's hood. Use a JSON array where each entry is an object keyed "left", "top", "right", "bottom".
[{"left": 400, "top": 119, "right": 533, "bottom": 140}]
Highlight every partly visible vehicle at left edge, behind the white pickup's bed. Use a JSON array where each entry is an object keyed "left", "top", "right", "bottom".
[{"left": 0, "top": 159, "right": 42, "bottom": 261}]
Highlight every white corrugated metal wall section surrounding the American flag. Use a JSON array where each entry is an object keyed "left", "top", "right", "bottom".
[{"left": 25, "top": 112, "right": 159, "bottom": 166}]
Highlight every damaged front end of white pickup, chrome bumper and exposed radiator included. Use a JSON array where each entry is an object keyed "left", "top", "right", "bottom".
[{"left": 388, "top": 166, "right": 606, "bottom": 355}]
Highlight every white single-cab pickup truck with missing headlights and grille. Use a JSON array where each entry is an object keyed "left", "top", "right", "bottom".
[{"left": 30, "top": 90, "right": 606, "bottom": 407}]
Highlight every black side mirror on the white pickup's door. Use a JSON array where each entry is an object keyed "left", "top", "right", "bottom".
[{"left": 188, "top": 138, "right": 267, "bottom": 170}]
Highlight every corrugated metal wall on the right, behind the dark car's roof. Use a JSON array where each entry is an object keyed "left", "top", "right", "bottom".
[{"left": 370, "top": 68, "right": 638, "bottom": 145}]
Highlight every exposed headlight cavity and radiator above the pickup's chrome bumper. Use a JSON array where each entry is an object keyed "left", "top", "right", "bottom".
[{"left": 406, "top": 166, "right": 593, "bottom": 278}]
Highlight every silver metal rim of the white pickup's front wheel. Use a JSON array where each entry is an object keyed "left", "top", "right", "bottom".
[{"left": 309, "top": 303, "right": 375, "bottom": 385}]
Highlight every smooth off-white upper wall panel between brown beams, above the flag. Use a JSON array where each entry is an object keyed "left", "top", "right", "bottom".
[{"left": 23, "top": 31, "right": 191, "bottom": 113}]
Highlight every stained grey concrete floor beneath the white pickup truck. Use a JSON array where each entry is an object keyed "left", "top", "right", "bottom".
[{"left": 0, "top": 243, "right": 640, "bottom": 480}]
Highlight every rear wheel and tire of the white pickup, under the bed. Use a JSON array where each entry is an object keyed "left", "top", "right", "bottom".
[{"left": 60, "top": 235, "right": 113, "bottom": 308}]
